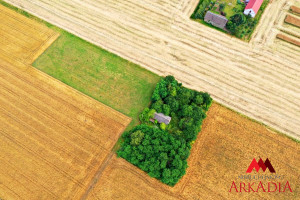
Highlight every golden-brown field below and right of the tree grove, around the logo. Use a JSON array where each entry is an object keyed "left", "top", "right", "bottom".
[{"left": 87, "top": 103, "right": 300, "bottom": 200}]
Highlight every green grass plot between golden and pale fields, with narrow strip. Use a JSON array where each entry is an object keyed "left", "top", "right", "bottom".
[{"left": 0, "top": 0, "right": 160, "bottom": 129}]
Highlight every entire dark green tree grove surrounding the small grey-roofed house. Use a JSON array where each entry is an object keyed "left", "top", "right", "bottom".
[{"left": 118, "top": 76, "right": 212, "bottom": 186}]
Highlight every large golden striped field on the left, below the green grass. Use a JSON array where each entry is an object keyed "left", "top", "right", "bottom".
[{"left": 0, "top": 6, "right": 131, "bottom": 200}]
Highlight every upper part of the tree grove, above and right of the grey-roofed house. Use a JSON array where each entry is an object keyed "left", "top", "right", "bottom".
[{"left": 140, "top": 76, "right": 212, "bottom": 143}]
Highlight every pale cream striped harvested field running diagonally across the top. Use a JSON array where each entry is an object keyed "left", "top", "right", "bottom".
[{"left": 6, "top": 0, "right": 300, "bottom": 139}]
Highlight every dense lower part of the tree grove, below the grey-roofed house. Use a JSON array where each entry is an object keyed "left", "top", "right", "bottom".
[{"left": 117, "top": 124, "right": 191, "bottom": 186}]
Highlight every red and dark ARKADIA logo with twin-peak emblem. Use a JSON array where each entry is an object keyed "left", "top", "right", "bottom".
[{"left": 229, "top": 158, "right": 293, "bottom": 192}]
